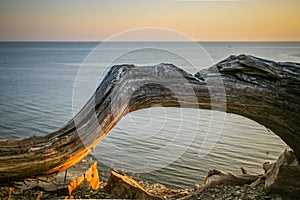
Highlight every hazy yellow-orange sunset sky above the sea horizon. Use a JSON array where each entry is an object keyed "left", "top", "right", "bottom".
[{"left": 0, "top": 0, "right": 300, "bottom": 41}]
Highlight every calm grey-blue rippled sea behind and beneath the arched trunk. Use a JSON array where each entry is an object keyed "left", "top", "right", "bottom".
[{"left": 0, "top": 42, "right": 300, "bottom": 188}]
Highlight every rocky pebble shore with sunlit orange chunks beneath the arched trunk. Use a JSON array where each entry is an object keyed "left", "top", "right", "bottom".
[{"left": 0, "top": 157, "right": 294, "bottom": 200}]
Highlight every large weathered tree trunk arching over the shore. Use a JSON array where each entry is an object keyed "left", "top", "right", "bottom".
[{"left": 0, "top": 55, "right": 300, "bottom": 182}]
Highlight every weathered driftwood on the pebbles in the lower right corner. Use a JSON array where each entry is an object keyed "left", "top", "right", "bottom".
[{"left": 180, "top": 149, "right": 300, "bottom": 200}]
